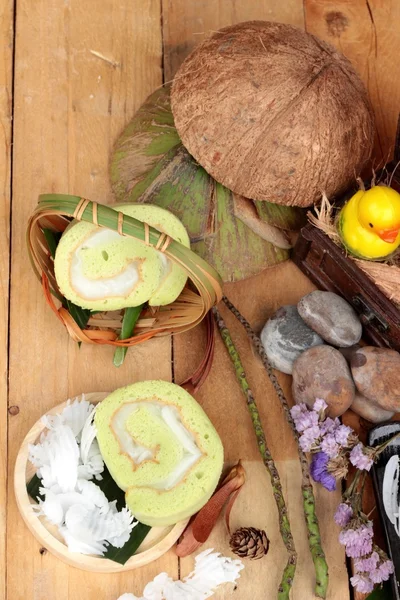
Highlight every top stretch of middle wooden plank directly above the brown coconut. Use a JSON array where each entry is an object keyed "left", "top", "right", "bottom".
[{"left": 162, "top": 0, "right": 304, "bottom": 81}]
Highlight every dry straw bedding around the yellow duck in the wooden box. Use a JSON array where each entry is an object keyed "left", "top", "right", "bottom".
[{"left": 307, "top": 194, "right": 400, "bottom": 304}]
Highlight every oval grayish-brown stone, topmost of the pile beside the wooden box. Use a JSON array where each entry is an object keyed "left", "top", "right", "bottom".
[{"left": 297, "top": 290, "right": 362, "bottom": 347}]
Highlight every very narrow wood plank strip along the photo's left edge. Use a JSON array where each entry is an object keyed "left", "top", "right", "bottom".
[{"left": 0, "top": 0, "right": 14, "bottom": 600}]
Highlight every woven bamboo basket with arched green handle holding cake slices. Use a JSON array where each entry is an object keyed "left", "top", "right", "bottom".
[{"left": 27, "top": 194, "right": 222, "bottom": 347}]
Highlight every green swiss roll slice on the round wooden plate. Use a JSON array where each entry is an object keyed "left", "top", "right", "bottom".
[{"left": 95, "top": 381, "right": 223, "bottom": 526}]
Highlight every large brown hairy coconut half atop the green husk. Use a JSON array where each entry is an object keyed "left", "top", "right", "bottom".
[{"left": 171, "top": 21, "right": 374, "bottom": 206}]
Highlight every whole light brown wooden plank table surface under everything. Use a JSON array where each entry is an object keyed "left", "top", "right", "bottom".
[{"left": 0, "top": 0, "right": 400, "bottom": 600}]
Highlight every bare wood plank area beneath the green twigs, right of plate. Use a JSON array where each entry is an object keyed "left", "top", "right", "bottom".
[{"left": 174, "top": 262, "right": 349, "bottom": 600}]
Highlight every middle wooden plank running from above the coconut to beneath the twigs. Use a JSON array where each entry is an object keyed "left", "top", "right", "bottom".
[{"left": 163, "top": 0, "right": 349, "bottom": 600}]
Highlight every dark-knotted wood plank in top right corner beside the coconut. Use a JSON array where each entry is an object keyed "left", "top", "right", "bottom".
[{"left": 304, "top": 0, "right": 400, "bottom": 168}]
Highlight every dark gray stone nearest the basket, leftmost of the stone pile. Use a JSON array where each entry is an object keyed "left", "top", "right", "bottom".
[{"left": 261, "top": 305, "right": 324, "bottom": 375}]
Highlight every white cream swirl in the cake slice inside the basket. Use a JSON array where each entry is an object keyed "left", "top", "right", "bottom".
[{"left": 70, "top": 229, "right": 139, "bottom": 300}]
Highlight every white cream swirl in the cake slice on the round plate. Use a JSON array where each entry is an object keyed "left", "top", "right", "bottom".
[{"left": 111, "top": 402, "right": 202, "bottom": 490}]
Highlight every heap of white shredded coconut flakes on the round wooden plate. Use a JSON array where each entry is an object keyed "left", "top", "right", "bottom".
[{"left": 29, "top": 396, "right": 137, "bottom": 556}]
